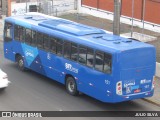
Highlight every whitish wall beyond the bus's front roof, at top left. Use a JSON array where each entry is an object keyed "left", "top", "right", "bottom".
[{"left": 11, "top": 0, "right": 75, "bottom": 16}]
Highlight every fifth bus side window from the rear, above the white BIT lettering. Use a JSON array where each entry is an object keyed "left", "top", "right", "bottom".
[{"left": 71, "top": 43, "right": 78, "bottom": 61}]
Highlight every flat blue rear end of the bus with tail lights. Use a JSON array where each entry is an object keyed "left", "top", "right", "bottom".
[{"left": 115, "top": 46, "right": 156, "bottom": 102}]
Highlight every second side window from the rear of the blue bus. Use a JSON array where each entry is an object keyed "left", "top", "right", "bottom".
[{"left": 95, "top": 51, "right": 104, "bottom": 72}]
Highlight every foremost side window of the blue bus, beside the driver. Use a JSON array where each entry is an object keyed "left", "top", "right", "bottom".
[{"left": 4, "top": 22, "right": 13, "bottom": 42}]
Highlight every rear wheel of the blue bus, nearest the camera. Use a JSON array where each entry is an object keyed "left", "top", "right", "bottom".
[{"left": 66, "top": 77, "right": 79, "bottom": 96}]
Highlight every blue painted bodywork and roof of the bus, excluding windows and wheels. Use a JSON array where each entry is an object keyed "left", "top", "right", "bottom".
[{"left": 4, "top": 15, "right": 156, "bottom": 103}]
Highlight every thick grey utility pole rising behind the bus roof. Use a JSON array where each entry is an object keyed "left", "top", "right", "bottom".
[{"left": 113, "top": 0, "right": 121, "bottom": 35}]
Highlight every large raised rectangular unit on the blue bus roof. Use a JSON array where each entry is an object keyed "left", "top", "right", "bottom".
[{"left": 39, "top": 19, "right": 105, "bottom": 36}]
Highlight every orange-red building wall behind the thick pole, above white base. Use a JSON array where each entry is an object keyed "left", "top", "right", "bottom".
[{"left": 81, "top": 0, "right": 160, "bottom": 25}]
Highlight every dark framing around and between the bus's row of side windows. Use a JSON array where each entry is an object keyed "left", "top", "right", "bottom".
[{"left": 11, "top": 25, "right": 112, "bottom": 74}]
